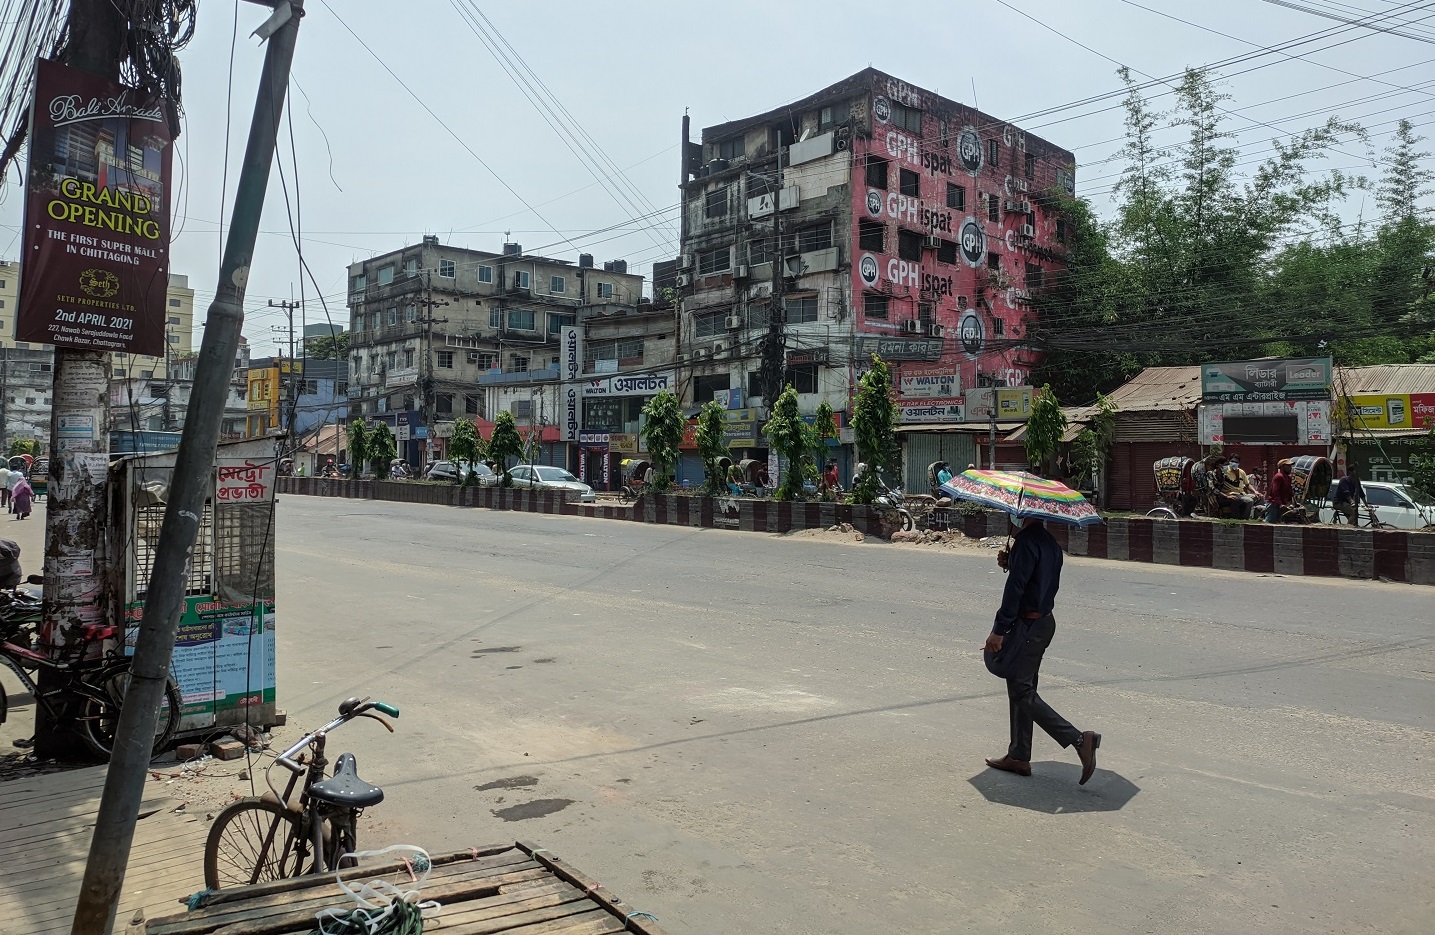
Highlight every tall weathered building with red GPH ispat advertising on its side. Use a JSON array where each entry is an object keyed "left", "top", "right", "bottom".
[{"left": 677, "top": 69, "right": 1075, "bottom": 486}]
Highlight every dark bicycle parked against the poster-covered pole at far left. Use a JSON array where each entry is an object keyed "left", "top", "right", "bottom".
[{"left": 0, "top": 605, "right": 182, "bottom": 760}]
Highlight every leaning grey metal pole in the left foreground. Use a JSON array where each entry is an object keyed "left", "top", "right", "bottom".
[{"left": 70, "top": 0, "right": 304, "bottom": 935}]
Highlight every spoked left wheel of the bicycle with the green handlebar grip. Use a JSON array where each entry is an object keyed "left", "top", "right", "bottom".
[{"left": 204, "top": 799, "right": 309, "bottom": 889}]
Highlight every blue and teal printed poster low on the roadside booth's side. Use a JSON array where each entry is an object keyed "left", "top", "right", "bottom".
[{"left": 125, "top": 595, "right": 274, "bottom": 730}]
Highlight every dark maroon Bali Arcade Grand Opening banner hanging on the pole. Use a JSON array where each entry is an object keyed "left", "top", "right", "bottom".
[{"left": 14, "top": 60, "right": 172, "bottom": 357}]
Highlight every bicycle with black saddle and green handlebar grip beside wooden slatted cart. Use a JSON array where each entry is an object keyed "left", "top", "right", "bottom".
[{"left": 204, "top": 698, "right": 399, "bottom": 889}]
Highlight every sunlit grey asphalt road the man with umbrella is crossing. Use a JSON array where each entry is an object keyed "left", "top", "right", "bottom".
[{"left": 278, "top": 496, "right": 1435, "bottom": 935}]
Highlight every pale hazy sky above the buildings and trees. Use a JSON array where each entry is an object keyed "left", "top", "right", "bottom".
[{"left": 0, "top": 0, "right": 1435, "bottom": 353}]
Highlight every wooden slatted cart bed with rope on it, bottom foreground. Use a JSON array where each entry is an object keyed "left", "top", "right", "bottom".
[{"left": 122, "top": 842, "right": 663, "bottom": 935}]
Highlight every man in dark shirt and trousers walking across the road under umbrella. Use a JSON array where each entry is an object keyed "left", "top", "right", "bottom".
[{"left": 986, "top": 518, "right": 1101, "bottom": 786}]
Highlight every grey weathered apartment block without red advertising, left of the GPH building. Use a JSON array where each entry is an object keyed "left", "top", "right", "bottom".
[{"left": 349, "top": 237, "right": 642, "bottom": 466}]
